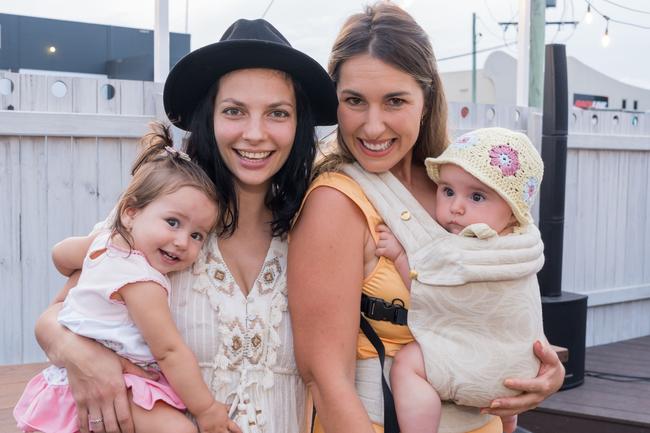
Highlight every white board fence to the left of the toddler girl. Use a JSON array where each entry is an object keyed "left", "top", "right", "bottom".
[{"left": 0, "top": 111, "right": 154, "bottom": 364}]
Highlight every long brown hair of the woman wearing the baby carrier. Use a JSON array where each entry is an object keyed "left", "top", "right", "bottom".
[{"left": 315, "top": 2, "right": 449, "bottom": 175}]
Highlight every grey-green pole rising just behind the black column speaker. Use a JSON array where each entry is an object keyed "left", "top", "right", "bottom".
[{"left": 528, "top": 0, "right": 546, "bottom": 108}]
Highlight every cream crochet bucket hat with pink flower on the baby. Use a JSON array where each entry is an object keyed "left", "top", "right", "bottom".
[{"left": 425, "top": 128, "right": 544, "bottom": 227}]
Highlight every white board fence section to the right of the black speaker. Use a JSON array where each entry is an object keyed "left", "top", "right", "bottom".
[{"left": 562, "top": 109, "right": 650, "bottom": 346}]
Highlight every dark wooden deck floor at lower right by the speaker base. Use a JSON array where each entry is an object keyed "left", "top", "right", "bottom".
[{"left": 519, "top": 336, "right": 650, "bottom": 433}]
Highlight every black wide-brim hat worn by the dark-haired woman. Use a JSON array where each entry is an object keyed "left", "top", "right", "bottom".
[{"left": 163, "top": 19, "right": 338, "bottom": 131}]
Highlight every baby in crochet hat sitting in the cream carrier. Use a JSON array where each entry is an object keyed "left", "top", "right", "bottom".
[{"left": 376, "top": 128, "right": 544, "bottom": 433}]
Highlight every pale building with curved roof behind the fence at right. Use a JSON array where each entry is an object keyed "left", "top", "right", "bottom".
[{"left": 441, "top": 51, "right": 650, "bottom": 111}]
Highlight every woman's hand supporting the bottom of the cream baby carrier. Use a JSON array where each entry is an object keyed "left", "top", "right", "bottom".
[{"left": 481, "top": 341, "right": 564, "bottom": 417}]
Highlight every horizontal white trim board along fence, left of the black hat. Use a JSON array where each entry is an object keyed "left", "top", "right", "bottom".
[{"left": 0, "top": 111, "right": 156, "bottom": 138}]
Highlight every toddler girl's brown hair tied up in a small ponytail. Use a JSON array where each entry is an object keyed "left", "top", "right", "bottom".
[{"left": 111, "top": 122, "right": 218, "bottom": 248}]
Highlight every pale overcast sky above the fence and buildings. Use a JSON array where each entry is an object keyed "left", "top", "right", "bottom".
[{"left": 0, "top": 0, "right": 650, "bottom": 88}]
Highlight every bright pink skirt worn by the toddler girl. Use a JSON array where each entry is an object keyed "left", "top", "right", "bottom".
[{"left": 14, "top": 366, "right": 185, "bottom": 433}]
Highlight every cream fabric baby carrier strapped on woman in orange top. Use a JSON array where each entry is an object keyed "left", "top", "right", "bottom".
[{"left": 343, "top": 163, "right": 545, "bottom": 433}]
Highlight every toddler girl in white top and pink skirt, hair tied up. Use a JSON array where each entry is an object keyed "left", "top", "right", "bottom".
[{"left": 14, "top": 125, "right": 240, "bottom": 433}]
